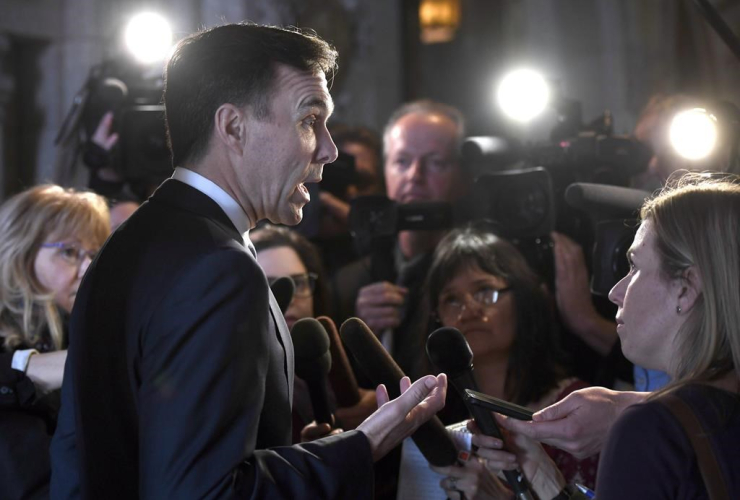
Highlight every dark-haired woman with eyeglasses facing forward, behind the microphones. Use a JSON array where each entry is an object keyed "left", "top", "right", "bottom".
[{"left": 421, "top": 225, "right": 598, "bottom": 500}]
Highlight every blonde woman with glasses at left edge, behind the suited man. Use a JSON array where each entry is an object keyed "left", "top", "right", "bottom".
[{"left": 0, "top": 185, "right": 110, "bottom": 499}]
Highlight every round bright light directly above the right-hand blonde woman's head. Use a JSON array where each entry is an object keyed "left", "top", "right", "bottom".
[{"left": 668, "top": 108, "right": 717, "bottom": 160}]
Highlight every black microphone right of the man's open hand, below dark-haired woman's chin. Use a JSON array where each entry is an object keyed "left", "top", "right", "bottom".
[{"left": 427, "top": 327, "right": 532, "bottom": 499}]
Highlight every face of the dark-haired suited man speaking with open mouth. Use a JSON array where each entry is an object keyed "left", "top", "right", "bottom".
[{"left": 236, "top": 65, "right": 337, "bottom": 225}]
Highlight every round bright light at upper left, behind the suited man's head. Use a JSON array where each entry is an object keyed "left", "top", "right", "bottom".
[{"left": 124, "top": 12, "right": 172, "bottom": 63}]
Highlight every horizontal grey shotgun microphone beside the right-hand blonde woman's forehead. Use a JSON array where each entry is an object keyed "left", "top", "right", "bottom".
[{"left": 565, "top": 182, "right": 650, "bottom": 217}]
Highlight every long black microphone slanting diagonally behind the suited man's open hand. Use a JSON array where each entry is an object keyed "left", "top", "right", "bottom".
[{"left": 339, "top": 318, "right": 457, "bottom": 467}]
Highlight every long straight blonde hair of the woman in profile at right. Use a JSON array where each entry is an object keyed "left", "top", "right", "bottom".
[{"left": 640, "top": 173, "right": 740, "bottom": 389}]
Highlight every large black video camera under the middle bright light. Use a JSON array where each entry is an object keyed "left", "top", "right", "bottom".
[{"left": 462, "top": 113, "right": 651, "bottom": 284}]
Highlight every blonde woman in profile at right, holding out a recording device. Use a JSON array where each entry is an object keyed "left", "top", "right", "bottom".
[{"left": 474, "top": 174, "right": 740, "bottom": 500}]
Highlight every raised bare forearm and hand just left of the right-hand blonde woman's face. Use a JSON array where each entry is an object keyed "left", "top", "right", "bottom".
[{"left": 550, "top": 232, "right": 617, "bottom": 356}]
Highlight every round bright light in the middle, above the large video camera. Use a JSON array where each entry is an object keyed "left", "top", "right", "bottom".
[{"left": 496, "top": 69, "right": 550, "bottom": 122}]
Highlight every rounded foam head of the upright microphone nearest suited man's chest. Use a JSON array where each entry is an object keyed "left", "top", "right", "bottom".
[{"left": 290, "top": 318, "right": 331, "bottom": 379}]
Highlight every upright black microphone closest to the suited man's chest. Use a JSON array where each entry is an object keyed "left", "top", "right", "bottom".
[{"left": 290, "top": 318, "right": 332, "bottom": 425}]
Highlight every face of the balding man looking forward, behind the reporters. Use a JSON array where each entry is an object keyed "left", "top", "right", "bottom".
[{"left": 385, "top": 113, "right": 462, "bottom": 203}]
